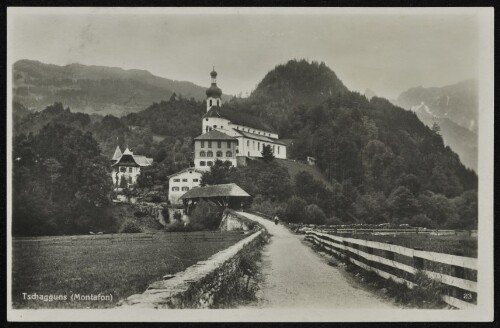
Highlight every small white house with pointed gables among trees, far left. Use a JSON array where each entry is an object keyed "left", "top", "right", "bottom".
[{"left": 111, "top": 146, "right": 153, "bottom": 188}]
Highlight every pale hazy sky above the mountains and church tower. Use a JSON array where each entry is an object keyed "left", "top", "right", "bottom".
[{"left": 8, "top": 8, "right": 479, "bottom": 98}]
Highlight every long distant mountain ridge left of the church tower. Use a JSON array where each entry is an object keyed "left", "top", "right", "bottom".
[{"left": 13, "top": 60, "right": 228, "bottom": 116}]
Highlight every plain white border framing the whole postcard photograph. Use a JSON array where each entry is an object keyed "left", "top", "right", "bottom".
[{"left": 7, "top": 7, "right": 494, "bottom": 322}]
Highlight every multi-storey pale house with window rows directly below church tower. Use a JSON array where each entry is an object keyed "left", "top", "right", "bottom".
[{"left": 194, "top": 130, "right": 238, "bottom": 171}]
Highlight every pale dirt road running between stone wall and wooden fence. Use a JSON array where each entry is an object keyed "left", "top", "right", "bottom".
[{"left": 240, "top": 212, "right": 396, "bottom": 309}]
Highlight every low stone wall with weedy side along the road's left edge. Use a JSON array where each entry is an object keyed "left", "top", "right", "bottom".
[{"left": 119, "top": 230, "right": 264, "bottom": 309}]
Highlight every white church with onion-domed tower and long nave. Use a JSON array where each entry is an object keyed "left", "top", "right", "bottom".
[{"left": 200, "top": 71, "right": 287, "bottom": 159}]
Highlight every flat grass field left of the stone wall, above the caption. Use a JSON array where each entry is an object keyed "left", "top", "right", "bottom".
[{"left": 12, "top": 232, "right": 245, "bottom": 308}]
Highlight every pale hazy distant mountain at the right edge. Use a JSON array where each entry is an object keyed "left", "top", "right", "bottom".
[{"left": 393, "top": 79, "right": 478, "bottom": 170}]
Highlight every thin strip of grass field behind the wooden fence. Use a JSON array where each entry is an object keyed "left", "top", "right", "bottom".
[{"left": 336, "top": 233, "right": 477, "bottom": 258}]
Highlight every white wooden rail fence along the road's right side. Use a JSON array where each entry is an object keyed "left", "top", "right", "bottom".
[{"left": 306, "top": 231, "right": 478, "bottom": 309}]
